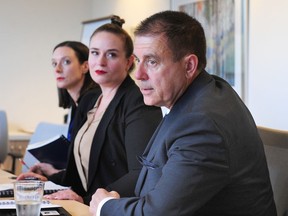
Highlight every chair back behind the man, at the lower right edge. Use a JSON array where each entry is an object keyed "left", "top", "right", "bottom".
[{"left": 258, "top": 126, "right": 288, "bottom": 216}]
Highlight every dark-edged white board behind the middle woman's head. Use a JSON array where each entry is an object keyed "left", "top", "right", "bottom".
[{"left": 81, "top": 16, "right": 111, "bottom": 46}]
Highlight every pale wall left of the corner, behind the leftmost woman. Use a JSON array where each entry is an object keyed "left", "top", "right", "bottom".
[{"left": 0, "top": 0, "right": 92, "bottom": 132}]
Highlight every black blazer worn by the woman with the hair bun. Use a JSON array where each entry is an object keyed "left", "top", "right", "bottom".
[{"left": 48, "top": 76, "right": 162, "bottom": 204}]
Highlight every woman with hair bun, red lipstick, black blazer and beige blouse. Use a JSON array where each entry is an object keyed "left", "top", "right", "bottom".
[{"left": 17, "top": 16, "right": 162, "bottom": 204}]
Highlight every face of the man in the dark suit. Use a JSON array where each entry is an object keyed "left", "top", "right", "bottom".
[{"left": 134, "top": 36, "right": 187, "bottom": 108}]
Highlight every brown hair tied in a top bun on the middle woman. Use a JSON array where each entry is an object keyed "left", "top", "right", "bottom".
[{"left": 90, "top": 15, "right": 135, "bottom": 72}]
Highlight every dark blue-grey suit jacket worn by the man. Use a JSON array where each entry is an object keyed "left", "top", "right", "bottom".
[{"left": 101, "top": 72, "right": 276, "bottom": 216}]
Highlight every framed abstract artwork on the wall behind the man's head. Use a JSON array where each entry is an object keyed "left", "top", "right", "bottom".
[{"left": 171, "top": 0, "right": 248, "bottom": 100}]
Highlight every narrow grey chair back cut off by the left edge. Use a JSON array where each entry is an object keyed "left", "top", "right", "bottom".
[{"left": 0, "top": 110, "right": 8, "bottom": 163}]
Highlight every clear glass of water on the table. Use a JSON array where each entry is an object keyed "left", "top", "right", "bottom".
[{"left": 14, "top": 180, "right": 44, "bottom": 216}]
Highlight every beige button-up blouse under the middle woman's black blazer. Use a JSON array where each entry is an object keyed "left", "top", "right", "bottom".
[{"left": 74, "top": 95, "right": 104, "bottom": 191}]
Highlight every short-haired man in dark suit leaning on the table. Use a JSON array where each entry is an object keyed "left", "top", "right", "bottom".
[{"left": 90, "top": 11, "right": 276, "bottom": 216}]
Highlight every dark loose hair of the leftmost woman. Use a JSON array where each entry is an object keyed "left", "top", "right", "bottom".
[{"left": 53, "top": 41, "right": 98, "bottom": 109}]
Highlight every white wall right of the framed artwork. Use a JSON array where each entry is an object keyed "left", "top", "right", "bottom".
[{"left": 247, "top": 0, "right": 288, "bottom": 130}]
